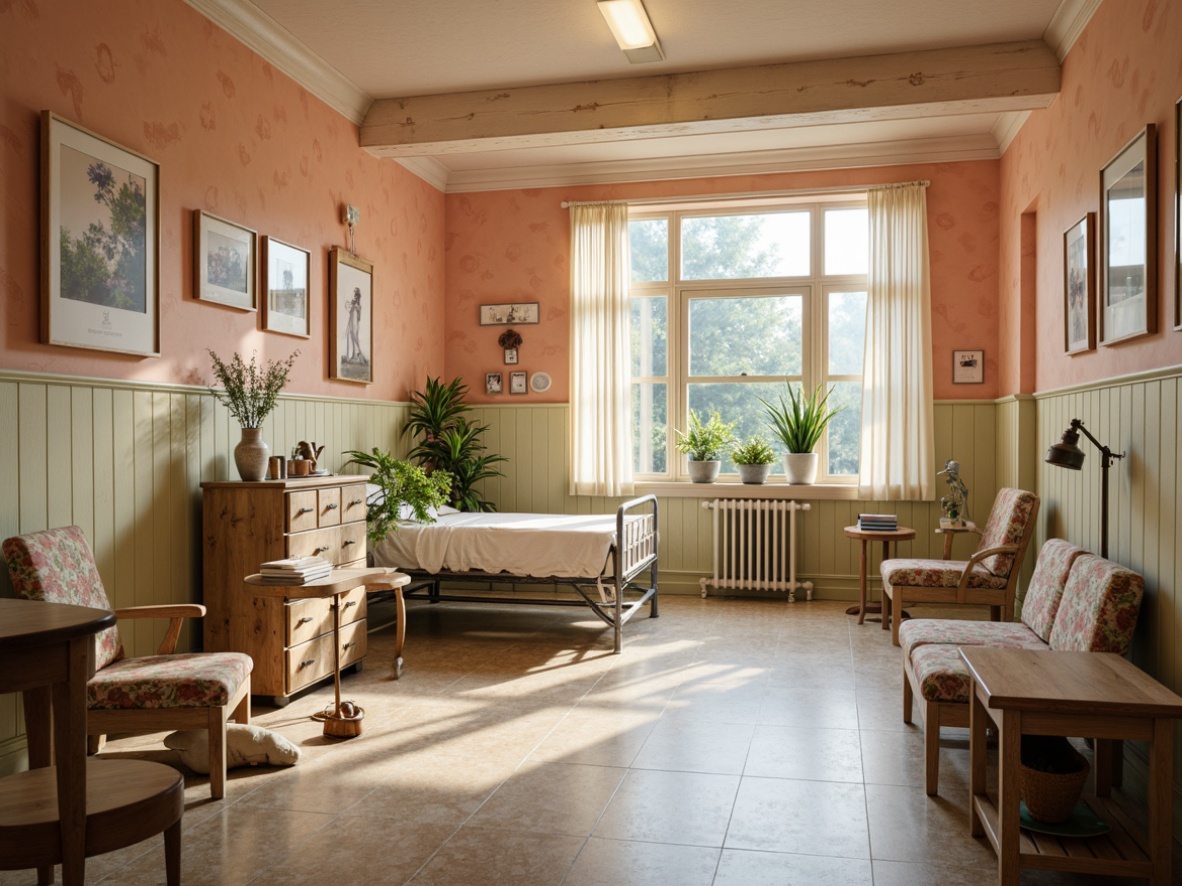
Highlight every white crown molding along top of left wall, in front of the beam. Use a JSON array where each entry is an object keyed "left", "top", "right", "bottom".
[{"left": 184, "top": 0, "right": 374, "bottom": 125}]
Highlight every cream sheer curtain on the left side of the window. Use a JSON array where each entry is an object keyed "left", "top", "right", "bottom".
[{"left": 571, "top": 203, "right": 632, "bottom": 496}]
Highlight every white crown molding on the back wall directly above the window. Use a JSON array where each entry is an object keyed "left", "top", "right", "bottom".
[{"left": 439, "top": 135, "right": 1000, "bottom": 194}]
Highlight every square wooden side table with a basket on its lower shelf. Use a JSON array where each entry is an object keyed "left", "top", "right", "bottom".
[{"left": 961, "top": 646, "right": 1182, "bottom": 886}]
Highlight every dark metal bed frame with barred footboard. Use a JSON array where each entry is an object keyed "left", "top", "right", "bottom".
[{"left": 401, "top": 495, "right": 658, "bottom": 652}]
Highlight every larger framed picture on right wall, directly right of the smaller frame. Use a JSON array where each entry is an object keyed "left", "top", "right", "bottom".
[{"left": 1098, "top": 123, "right": 1157, "bottom": 345}]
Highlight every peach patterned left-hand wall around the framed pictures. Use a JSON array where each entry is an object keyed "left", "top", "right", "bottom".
[{"left": 0, "top": 0, "right": 444, "bottom": 400}]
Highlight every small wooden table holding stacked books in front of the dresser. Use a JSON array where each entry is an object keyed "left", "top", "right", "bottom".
[{"left": 246, "top": 567, "right": 410, "bottom": 738}]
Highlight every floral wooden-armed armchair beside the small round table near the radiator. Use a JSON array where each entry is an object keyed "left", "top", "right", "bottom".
[{"left": 882, "top": 489, "right": 1039, "bottom": 646}]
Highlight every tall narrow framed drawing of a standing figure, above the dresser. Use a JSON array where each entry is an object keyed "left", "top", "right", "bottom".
[{"left": 329, "top": 246, "right": 374, "bottom": 384}]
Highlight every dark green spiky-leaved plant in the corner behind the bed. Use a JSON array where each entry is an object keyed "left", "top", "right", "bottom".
[{"left": 402, "top": 377, "right": 508, "bottom": 510}]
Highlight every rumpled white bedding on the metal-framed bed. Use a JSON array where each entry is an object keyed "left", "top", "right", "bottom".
[{"left": 374, "top": 513, "right": 616, "bottom": 578}]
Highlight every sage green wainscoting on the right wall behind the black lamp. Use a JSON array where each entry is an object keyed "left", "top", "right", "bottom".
[{"left": 1037, "top": 366, "right": 1182, "bottom": 839}]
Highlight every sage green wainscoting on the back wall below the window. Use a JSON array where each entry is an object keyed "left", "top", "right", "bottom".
[{"left": 473, "top": 400, "right": 1001, "bottom": 600}]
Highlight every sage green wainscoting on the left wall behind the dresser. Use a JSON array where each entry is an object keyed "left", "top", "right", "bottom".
[{"left": 0, "top": 372, "right": 407, "bottom": 774}]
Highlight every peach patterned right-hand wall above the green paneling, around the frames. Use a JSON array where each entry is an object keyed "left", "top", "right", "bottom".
[{"left": 999, "top": 0, "right": 1182, "bottom": 393}]
